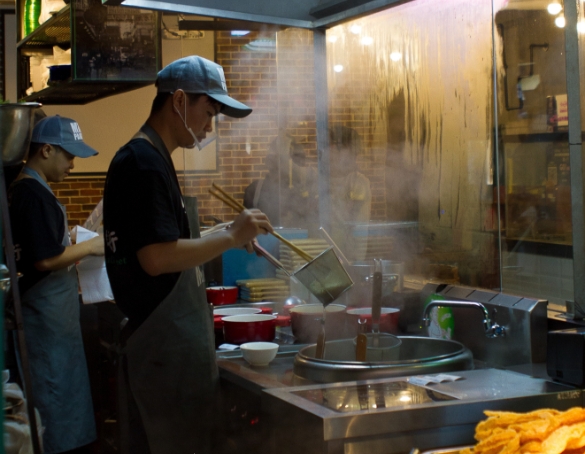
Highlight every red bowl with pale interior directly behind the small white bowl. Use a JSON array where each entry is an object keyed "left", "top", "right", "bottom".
[{"left": 222, "top": 314, "right": 276, "bottom": 344}]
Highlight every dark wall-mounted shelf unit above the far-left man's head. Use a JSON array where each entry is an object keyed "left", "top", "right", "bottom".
[{"left": 17, "top": 0, "right": 162, "bottom": 104}]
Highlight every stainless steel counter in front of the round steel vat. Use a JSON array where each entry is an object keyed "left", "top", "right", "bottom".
[{"left": 218, "top": 345, "right": 583, "bottom": 454}]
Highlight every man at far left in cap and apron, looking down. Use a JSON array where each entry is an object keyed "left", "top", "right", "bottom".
[{"left": 8, "top": 115, "right": 104, "bottom": 453}]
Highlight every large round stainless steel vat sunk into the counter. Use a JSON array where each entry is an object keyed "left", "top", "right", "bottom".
[{"left": 294, "top": 336, "right": 473, "bottom": 385}]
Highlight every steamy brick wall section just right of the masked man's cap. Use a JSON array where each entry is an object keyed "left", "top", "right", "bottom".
[{"left": 185, "top": 30, "right": 317, "bottom": 224}]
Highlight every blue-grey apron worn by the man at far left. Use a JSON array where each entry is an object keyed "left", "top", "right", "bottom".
[{"left": 21, "top": 167, "right": 96, "bottom": 453}]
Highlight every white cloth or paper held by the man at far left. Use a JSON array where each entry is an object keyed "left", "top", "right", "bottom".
[{"left": 75, "top": 226, "right": 114, "bottom": 304}]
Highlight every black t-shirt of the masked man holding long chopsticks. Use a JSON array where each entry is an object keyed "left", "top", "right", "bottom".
[{"left": 104, "top": 130, "right": 190, "bottom": 327}]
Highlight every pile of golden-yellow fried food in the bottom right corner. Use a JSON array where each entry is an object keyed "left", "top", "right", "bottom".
[{"left": 460, "top": 407, "right": 585, "bottom": 454}]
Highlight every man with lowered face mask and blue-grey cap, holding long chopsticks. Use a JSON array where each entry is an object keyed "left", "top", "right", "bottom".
[{"left": 104, "top": 56, "right": 272, "bottom": 454}]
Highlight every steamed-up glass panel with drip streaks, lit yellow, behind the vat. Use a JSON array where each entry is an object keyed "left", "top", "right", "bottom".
[{"left": 327, "top": 0, "right": 499, "bottom": 288}]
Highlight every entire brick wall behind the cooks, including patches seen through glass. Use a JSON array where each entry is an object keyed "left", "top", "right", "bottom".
[{"left": 53, "top": 29, "right": 385, "bottom": 231}]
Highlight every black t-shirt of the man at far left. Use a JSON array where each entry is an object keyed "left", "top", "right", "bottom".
[{"left": 8, "top": 178, "right": 65, "bottom": 294}]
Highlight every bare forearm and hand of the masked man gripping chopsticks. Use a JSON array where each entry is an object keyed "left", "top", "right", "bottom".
[{"left": 137, "top": 209, "right": 272, "bottom": 276}]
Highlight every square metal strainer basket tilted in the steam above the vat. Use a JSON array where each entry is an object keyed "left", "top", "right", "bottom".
[{"left": 293, "top": 248, "right": 353, "bottom": 306}]
